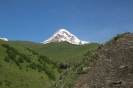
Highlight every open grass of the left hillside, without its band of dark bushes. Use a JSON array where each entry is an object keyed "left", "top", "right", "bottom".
[{"left": 0, "top": 40, "right": 59, "bottom": 88}]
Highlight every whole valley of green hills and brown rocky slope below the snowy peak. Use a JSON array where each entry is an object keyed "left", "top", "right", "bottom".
[{"left": 0, "top": 32, "right": 133, "bottom": 88}]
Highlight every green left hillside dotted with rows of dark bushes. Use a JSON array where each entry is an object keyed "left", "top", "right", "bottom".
[{"left": 0, "top": 40, "right": 60, "bottom": 88}]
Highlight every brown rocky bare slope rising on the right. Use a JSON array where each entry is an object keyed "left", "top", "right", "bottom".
[{"left": 75, "top": 33, "right": 133, "bottom": 88}]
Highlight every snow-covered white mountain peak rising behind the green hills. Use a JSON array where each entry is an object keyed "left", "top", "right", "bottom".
[{"left": 42, "top": 29, "right": 89, "bottom": 45}]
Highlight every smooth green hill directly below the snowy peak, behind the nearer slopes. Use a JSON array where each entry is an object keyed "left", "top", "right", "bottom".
[{"left": 11, "top": 41, "right": 99, "bottom": 62}]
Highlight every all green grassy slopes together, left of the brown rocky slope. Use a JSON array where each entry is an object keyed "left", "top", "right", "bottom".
[{"left": 0, "top": 40, "right": 99, "bottom": 88}]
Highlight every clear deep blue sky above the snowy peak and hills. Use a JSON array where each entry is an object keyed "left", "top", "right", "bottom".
[{"left": 0, "top": 0, "right": 133, "bottom": 43}]
